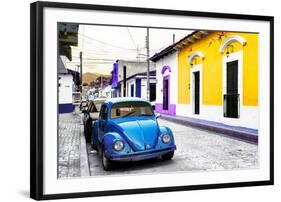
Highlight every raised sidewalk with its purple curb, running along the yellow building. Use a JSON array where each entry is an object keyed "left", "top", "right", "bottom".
[{"left": 160, "top": 114, "right": 258, "bottom": 144}]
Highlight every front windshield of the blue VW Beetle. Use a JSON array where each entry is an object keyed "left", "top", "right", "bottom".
[{"left": 110, "top": 102, "right": 153, "bottom": 119}]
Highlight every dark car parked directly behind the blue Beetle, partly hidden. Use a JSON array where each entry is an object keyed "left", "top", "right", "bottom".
[{"left": 82, "top": 98, "right": 106, "bottom": 142}]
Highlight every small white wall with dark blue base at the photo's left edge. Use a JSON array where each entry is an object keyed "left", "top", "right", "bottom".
[{"left": 58, "top": 74, "right": 73, "bottom": 104}]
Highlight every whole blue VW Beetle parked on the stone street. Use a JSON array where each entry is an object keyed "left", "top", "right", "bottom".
[{"left": 91, "top": 97, "right": 176, "bottom": 171}]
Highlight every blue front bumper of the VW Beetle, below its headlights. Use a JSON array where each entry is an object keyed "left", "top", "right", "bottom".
[{"left": 109, "top": 145, "right": 176, "bottom": 161}]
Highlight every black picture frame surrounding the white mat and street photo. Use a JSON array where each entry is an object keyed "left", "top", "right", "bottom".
[{"left": 30, "top": 2, "right": 274, "bottom": 200}]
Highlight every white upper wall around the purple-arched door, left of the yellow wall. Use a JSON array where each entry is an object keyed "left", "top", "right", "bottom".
[{"left": 156, "top": 52, "right": 178, "bottom": 104}]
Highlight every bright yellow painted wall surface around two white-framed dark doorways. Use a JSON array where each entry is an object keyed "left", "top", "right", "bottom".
[{"left": 178, "top": 32, "right": 258, "bottom": 106}]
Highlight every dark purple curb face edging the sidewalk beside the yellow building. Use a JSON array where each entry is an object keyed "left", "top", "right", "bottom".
[{"left": 160, "top": 115, "right": 258, "bottom": 144}]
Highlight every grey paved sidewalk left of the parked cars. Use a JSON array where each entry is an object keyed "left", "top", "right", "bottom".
[{"left": 58, "top": 112, "right": 89, "bottom": 178}]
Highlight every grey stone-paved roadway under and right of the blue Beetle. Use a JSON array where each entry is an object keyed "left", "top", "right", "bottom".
[{"left": 87, "top": 118, "right": 259, "bottom": 176}]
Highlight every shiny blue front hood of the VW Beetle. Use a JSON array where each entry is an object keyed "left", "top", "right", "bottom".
[{"left": 113, "top": 117, "right": 159, "bottom": 151}]
